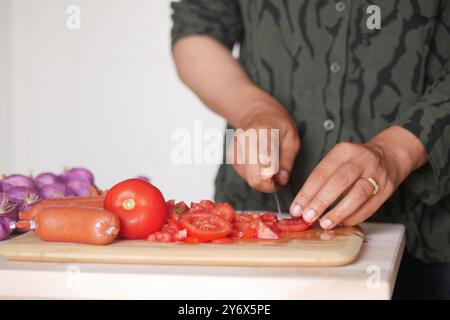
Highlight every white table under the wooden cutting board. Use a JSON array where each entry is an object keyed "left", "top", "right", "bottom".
[{"left": 0, "top": 223, "right": 405, "bottom": 299}]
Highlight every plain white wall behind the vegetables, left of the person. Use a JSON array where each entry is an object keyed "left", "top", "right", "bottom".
[{"left": 4, "top": 0, "right": 224, "bottom": 201}]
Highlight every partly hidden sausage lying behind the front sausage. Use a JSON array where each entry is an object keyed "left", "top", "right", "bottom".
[{"left": 19, "top": 196, "right": 104, "bottom": 220}]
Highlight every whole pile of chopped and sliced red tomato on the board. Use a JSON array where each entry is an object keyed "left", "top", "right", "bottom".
[{"left": 148, "top": 200, "right": 310, "bottom": 244}]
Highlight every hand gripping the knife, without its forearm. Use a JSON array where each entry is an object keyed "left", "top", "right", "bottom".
[{"left": 227, "top": 100, "right": 300, "bottom": 192}]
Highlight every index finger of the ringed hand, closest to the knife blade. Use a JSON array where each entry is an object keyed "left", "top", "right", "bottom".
[{"left": 289, "top": 149, "right": 345, "bottom": 217}]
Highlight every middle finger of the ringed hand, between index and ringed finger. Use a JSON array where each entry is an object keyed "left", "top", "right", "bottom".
[{"left": 303, "top": 162, "right": 363, "bottom": 223}]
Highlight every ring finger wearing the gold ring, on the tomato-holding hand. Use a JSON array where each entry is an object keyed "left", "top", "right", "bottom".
[{"left": 320, "top": 175, "right": 378, "bottom": 229}]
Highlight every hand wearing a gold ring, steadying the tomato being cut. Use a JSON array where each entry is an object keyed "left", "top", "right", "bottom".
[{"left": 290, "top": 126, "right": 427, "bottom": 229}]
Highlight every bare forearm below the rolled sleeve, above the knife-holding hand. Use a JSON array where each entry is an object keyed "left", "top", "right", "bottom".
[{"left": 173, "top": 36, "right": 285, "bottom": 127}]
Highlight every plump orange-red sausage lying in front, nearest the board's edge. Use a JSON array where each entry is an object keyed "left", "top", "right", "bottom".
[{"left": 29, "top": 207, "right": 120, "bottom": 245}]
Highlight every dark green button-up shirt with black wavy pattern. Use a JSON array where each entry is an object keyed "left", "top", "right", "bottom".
[{"left": 172, "top": 0, "right": 450, "bottom": 262}]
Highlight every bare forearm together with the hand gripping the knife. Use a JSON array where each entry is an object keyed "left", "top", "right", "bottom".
[{"left": 173, "top": 35, "right": 300, "bottom": 192}]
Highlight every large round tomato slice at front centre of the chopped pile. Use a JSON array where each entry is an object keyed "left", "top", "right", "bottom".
[{"left": 179, "top": 213, "right": 231, "bottom": 242}]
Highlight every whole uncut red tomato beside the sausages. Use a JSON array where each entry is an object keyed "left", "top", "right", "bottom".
[{"left": 104, "top": 179, "right": 167, "bottom": 239}]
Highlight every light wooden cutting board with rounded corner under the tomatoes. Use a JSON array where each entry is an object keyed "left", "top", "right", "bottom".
[{"left": 0, "top": 228, "right": 363, "bottom": 267}]
